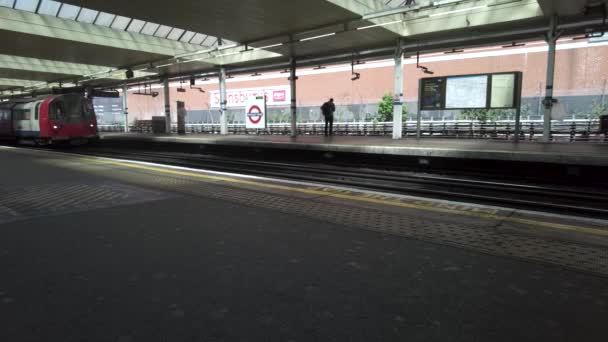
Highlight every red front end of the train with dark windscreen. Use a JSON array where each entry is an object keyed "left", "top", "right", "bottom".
[{"left": 40, "top": 94, "right": 99, "bottom": 144}]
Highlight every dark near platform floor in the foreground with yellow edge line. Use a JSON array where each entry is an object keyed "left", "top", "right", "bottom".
[{"left": 0, "top": 147, "right": 608, "bottom": 342}]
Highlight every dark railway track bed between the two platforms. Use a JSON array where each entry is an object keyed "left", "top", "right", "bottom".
[{"left": 51, "top": 148, "right": 608, "bottom": 219}]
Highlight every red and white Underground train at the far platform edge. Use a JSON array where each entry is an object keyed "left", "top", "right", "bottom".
[{"left": 0, "top": 93, "right": 99, "bottom": 145}]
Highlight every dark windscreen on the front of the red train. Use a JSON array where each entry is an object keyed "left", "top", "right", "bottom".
[{"left": 49, "top": 94, "right": 95, "bottom": 124}]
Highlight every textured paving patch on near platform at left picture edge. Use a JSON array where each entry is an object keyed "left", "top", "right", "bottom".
[{"left": 0, "top": 182, "right": 171, "bottom": 224}]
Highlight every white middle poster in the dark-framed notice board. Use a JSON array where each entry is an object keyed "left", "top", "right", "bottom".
[{"left": 445, "top": 75, "right": 488, "bottom": 109}]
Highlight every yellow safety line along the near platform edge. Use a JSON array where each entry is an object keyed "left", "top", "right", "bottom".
[{"left": 83, "top": 158, "right": 608, "bottom": 236}]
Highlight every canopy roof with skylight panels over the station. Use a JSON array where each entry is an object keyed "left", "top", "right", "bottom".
[{"left": 0, "top": 0, "right": 607, "bottom": 95}]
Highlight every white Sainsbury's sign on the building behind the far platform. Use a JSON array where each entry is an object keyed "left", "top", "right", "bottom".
[{"left": 209, "top": 86, "right": 291, "bottom": 108}]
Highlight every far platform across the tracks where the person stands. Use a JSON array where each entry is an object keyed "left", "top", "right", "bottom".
[{"left": 102, "top": 133, "right": 608, "bottom": 166}]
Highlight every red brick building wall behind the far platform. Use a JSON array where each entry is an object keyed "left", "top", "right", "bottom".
[{"left": 104, "top": 39, "right": 608, "bottom": 122}]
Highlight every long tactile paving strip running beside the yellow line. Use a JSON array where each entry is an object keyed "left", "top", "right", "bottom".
[{"left": 89, "top": 170, "right": 608, "bottom": 275}]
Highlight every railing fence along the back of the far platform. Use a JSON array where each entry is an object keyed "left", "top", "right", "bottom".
[{"left": 99, "top": 120, "right": 608, "bottom": 142}]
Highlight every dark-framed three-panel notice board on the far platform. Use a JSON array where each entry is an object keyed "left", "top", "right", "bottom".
[{"left": 419, "top": 72, "right": 522, "bottom": 110}]
